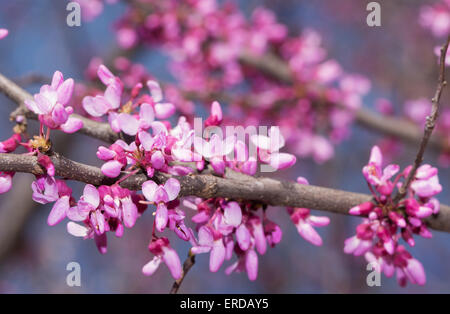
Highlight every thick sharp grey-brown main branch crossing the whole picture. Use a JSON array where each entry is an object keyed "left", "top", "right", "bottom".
[{"left": 0, "top": 154, "right": 450, "bottom": 232}]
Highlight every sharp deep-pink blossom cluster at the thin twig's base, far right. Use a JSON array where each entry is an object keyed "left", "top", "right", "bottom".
[{"left": 344, "top": 146, "right": 442, "bottom": 286}]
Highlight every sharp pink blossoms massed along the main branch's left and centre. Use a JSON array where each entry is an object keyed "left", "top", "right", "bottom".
[{"left": 0, "top": 60, "right": 322, "bottom": 280}]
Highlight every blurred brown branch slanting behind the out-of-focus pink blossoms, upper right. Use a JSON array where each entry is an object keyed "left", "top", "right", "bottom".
[{"left": 240, "top": 52, "right": 448, "bottom": 150}]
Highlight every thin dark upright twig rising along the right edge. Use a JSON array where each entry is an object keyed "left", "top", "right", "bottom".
[{"left": 394, "top": 35, "right": 450, "bottom": 201}]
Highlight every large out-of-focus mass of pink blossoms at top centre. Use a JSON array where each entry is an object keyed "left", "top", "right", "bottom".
[{"left": 103, "top": 0, "right": 370, "bottom": 162}]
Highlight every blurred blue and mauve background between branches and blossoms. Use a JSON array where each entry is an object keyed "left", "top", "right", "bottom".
[{"left": 0, "top": 0, "right": 450, "bottom": 293}]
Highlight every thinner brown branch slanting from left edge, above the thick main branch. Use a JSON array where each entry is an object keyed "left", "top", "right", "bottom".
[{"left": 0, "top": 74, "right": 119, "bottom": 143}]
